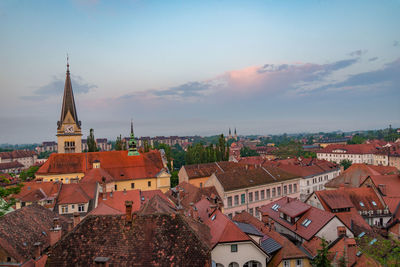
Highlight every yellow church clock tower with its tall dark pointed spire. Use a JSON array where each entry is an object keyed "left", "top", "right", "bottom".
[{"left": 57, "top": 58, "right": 82, "bottom": 153}]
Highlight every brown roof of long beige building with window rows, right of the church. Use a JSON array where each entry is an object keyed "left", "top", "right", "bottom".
[{"left": 215, "top": 166, "right": 298, "bottom": 191}]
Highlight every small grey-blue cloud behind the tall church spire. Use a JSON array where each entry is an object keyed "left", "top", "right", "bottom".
[{"left": 21, "top": 75, "right": 97, "bottom": 100}]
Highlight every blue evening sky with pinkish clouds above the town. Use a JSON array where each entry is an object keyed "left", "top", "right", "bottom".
[{"left": 0, "top": 0, "right": 400, "bottom": 143}]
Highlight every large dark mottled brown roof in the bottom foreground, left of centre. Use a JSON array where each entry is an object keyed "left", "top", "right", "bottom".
[{"left": 47, "top": 213, "right": 211, "bottom": 267}]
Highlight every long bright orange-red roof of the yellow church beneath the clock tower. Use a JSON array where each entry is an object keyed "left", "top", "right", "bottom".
[{"left": 37, "top": 151, "right": 164, "bottom": 180}]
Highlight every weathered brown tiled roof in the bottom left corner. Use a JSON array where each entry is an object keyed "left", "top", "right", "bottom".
[{"left": 0, "top": 204, "right": 68, "bottom": 262}]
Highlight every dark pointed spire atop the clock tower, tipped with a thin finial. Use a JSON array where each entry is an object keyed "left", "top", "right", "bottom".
[{"left": 57, "top": 55, "right": 81, "bottom": 129}]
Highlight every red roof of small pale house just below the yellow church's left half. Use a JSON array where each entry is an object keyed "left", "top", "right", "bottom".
[{"left": 58, "top": 183, "right": 97, "bottom": 204}]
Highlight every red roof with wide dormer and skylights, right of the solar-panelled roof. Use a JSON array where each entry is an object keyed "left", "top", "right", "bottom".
[{"left": 260, "top": 197, "right": 335, "bottom": 243}]
